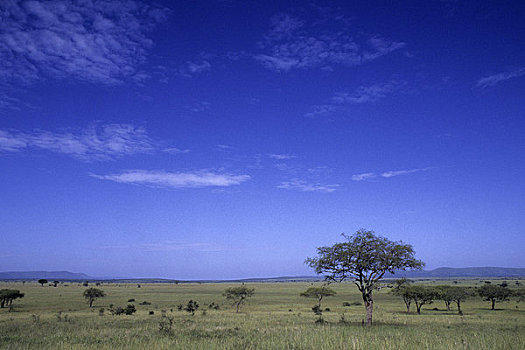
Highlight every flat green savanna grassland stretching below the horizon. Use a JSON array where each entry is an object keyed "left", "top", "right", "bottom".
[{"left": 0, "top": 280, "right": 525, "bottom": 350}]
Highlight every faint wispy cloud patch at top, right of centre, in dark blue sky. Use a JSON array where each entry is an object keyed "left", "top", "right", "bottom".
[{"left": 254, "top": 14, "right": 405, "bottom": 71}]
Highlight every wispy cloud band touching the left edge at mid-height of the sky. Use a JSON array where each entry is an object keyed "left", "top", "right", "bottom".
[{"left": 0, "top": 124, "right": 156, "bottom": 160}]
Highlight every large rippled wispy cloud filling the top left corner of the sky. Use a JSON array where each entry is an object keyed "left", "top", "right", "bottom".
[{"left": 0, "top": 0, "right": 168, "bottom": 85}]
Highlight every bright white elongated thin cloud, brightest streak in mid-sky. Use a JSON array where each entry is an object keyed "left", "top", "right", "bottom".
[{"left": 91, "top": 170, "right": 250, "bottom": 188}]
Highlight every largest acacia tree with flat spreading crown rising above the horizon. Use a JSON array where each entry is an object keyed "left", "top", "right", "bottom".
[{"left": 305, "top": 229, "right": 424, "bottom": 326}]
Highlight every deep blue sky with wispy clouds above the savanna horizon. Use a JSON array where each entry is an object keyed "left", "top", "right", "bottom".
[{"left": 0, "top": 0, "right": 525, "bottom": 279}]
